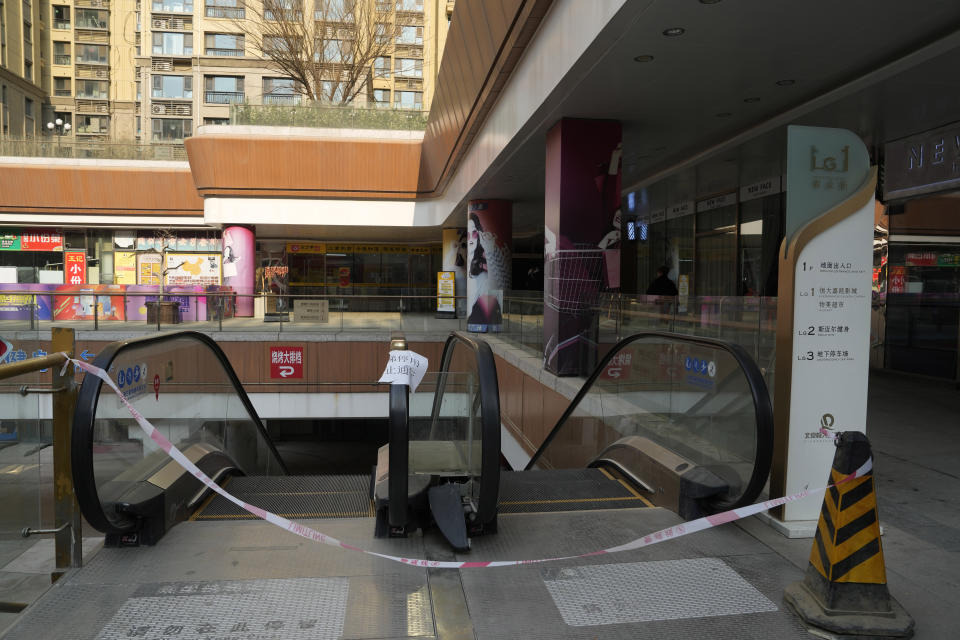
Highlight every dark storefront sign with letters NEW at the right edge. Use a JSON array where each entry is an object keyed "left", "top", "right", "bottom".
[{"left": 883, "top": 122, "right": 960, "bottom": 200}]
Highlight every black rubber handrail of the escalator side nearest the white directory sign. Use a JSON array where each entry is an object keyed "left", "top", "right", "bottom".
[{"left": 524, "top": 331, "right": 773, "bottom": 510}]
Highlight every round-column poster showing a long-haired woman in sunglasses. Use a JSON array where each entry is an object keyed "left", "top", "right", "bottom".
[{"left": 467, "top": 200, "right": 513, "bottom": 333}]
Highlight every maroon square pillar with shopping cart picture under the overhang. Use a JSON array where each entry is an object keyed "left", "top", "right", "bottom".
[{"left": 543, "top": 118, "right": 620, "bottom": 376}]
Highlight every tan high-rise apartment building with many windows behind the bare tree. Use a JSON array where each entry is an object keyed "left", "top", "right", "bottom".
[{"left": 0, "top": 0, "right": 454, "bottom": 143}]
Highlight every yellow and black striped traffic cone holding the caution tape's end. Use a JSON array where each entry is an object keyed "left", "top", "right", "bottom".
[{"left": 783, "top": 431, "right": 914, "bottom": 638}]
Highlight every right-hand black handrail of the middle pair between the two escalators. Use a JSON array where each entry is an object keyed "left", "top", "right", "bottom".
[{"left": 431, "top": 331, "right": 500, "bottom": 524}]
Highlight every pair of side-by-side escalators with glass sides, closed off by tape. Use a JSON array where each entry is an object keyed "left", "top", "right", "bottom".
[{"left": 72, "top": 332, "right": 772, "bottom": 550}]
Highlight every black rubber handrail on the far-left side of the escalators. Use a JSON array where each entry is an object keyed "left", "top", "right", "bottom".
[{"left": 70, "top": 331, "right": 288, "bottom": 533}]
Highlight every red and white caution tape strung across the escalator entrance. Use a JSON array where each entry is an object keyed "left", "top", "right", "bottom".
[{"left": 63, "top": 353, "right": 873, "bottom": 569}]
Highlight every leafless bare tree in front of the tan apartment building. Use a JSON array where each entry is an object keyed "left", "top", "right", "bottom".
[{"left": 234, "top": 0, "right": 397, "bottom": 104}]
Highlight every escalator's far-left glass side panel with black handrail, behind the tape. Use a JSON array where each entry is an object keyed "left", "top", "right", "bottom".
[{"left": 72, "top": 332, "right": 286, "bottom": 544}]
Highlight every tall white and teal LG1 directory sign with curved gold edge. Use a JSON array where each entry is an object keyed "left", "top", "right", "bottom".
[{"left": 770, "top": 126, "right": 877, "bottom": 536}]
